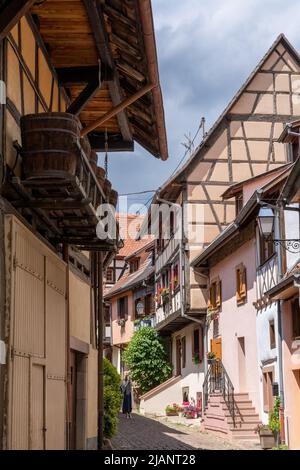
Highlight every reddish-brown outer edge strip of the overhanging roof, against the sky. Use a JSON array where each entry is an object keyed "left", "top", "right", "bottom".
[{"left": 137, "top": 0, "right": 168, "bottom": 160}]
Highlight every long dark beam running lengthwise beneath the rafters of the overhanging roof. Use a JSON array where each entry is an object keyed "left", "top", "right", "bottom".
[{"left": 83, "top": 0, "right": 132, "bottom": 142}]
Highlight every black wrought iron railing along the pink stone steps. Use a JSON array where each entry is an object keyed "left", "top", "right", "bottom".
[{"left": 203, "top": 360, "right": 242, "bottom": 427}]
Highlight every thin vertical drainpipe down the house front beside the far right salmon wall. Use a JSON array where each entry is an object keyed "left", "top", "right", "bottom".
[{"left": 274, "top": 209, "right": 285, "bottom": 444}]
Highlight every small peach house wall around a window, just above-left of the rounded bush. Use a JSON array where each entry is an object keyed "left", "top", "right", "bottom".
[{"left": 112, "top": 292, "right": 134, "bottom": 345}]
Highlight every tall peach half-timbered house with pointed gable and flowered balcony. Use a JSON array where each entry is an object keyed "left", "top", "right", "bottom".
[{"left": 139, "top": 35, "right": 300, "bottom": 418}]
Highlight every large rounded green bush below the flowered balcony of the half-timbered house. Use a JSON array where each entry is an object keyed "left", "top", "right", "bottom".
[{"left": 124, "top": 326, "right": 172, "bottom": 394}]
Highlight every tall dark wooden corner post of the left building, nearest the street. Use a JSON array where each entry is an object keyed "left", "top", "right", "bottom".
[{"left": 96, "top": 252, "right": 104, "bottom": 450}]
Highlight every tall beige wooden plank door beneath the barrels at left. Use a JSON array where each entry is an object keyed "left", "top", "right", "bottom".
[{"left": 6, "top": 217, "right": 66, "bottom": 449}]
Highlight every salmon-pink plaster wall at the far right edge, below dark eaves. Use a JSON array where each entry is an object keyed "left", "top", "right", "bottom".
[{"left": 282, "top": 302, "right": 300, "bottom": 450}]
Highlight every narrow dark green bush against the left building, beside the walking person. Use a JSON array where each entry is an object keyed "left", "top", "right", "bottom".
[{"left": 104, "top": 358, "right": 122, "bottom": 439}]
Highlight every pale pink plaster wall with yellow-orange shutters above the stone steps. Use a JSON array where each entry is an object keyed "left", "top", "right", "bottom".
[{"left": 210, "top": 239, "right": 260, "bottom": 411}]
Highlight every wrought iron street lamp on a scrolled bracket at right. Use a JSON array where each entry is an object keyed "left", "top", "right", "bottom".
[{"left": 257, "top": 205, "right": 300, "bottom": 253}]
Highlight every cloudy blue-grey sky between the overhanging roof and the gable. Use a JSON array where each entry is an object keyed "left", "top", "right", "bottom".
[{"left": 101, "top": 0, "right": 300, "bottom": 212}]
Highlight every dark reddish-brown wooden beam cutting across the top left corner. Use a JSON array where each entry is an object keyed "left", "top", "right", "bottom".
[{"left": 0, "top": 0, "right": 36, "bottom": 40}]
